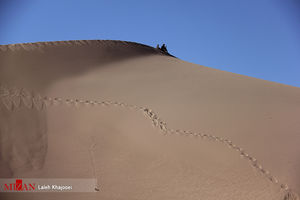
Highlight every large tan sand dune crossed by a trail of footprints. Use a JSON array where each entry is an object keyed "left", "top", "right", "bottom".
[{"left": 0, "top": 41, "right": 300, "bottom": 200}]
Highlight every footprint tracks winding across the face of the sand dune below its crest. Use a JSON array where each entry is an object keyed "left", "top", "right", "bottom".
[{"left": 0, "top": 84, "right": 299, "bottom": 200}]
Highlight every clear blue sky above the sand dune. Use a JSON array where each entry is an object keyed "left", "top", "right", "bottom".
[{"left": 0, "top": 0, "right": 300, "bottom": 87}]
